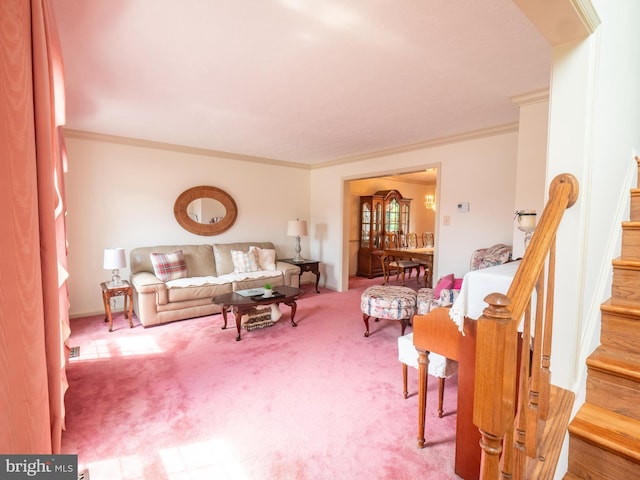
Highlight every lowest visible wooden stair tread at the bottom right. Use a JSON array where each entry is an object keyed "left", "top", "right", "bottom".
[{"left": 569, "top": 403, "right": 640, "bottom": 467}]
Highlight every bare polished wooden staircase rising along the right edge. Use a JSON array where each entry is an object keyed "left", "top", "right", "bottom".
[{"left": 564, "top": 162, "right": 640, "bottom": 480}]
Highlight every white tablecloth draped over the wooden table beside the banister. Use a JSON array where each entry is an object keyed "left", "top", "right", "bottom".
[{"left": 449, "top": 260, "right": 520, "bottom": 332}]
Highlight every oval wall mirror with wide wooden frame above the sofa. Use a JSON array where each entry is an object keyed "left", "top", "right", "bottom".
[{"left": 173, "top": 186, "right": 238, "bottom": 235}]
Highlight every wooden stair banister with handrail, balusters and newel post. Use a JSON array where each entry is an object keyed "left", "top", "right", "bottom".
[{"left": 473, "top": 174, "right": 578, "bottom": 479}]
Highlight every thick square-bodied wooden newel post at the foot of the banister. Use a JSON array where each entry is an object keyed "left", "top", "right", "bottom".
[{"left": 473, "top": 293, "right": 518, "bottom": 479}]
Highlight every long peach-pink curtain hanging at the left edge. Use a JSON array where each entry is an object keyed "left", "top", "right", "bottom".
[{"left": 0, "top": 0, "right": 69, "bottom": 454}]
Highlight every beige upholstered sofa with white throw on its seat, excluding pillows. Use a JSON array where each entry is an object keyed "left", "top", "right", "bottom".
[{"left": 129, "top": 242, "right": 300, "bottom": 327}]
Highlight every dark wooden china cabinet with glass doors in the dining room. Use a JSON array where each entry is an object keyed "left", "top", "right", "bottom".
[{"left": 356, "top": 190, "right": 411, "bottom": 278}]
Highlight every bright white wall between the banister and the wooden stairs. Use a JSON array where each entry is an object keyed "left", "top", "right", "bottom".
[{"left": 547, "top": 0, "right": 640, "bottom": 479}]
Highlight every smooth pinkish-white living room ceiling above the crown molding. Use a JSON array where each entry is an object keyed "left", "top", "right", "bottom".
[{"left": 51, "top": 0, "right": 551, "bottom": 167}]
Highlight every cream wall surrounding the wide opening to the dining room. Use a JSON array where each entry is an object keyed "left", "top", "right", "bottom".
[{"left": 311, "top": 132, "right": 517, "bottom": 291}]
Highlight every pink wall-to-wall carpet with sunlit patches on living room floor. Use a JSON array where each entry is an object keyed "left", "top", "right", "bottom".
[{"left": 63, "top": 278, "right": 459, "bottom": 480}]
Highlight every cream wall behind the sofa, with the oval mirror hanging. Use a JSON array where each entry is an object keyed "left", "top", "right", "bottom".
[{"left": 65, "top": 135, "right": 315, "bottom": 317}]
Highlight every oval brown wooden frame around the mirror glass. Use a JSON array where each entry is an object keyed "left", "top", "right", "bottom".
[{"left": 173, "top": 185, "right": 238, "bottom": 235}]
